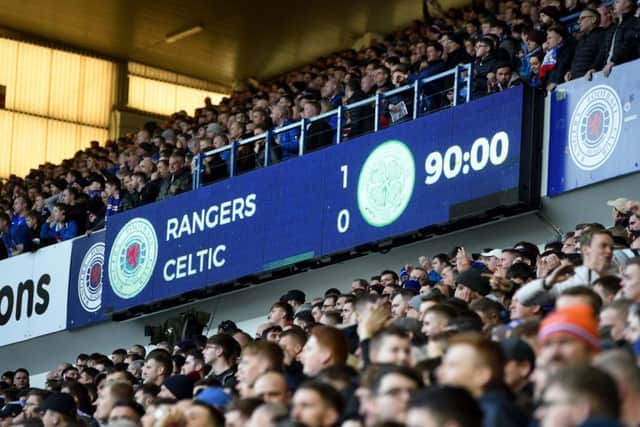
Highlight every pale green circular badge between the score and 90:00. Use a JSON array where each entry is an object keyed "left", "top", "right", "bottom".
[{"left": 358, "top": 140, "right": 416, "bottom": 227}]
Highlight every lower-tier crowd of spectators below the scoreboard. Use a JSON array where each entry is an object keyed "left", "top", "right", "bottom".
[{"left": 0, "top": 199, "right": 640, "bottom": 427}]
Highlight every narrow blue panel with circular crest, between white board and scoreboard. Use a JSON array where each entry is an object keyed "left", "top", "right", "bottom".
[{"left": 67, "top": 230, "right": 108, "bottom": 329}]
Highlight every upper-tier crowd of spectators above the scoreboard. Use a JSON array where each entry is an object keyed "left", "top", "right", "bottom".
[{"left": 0, "top": 0, "right": 640, "bottom": 259}]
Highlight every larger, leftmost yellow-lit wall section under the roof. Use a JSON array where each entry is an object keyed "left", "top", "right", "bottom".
[{"left": 0, "top": 38, "right": 115, "bottom": 177}]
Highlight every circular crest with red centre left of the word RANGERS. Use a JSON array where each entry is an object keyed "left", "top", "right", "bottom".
[{"left": 109, "top": 218, "right": 158, "bottom": 299}]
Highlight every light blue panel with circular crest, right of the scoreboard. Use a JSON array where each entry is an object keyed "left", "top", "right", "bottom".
[{"left": 547, "top": 61, "right": 640, "bottom": 196}]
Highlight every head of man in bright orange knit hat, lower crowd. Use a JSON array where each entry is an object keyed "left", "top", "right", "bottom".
[{"left": 537, "top": 304, "right": 600, "bottom": 371}]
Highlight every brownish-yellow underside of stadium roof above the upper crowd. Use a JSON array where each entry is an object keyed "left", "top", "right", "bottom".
[{"left": 0, "top": 0, "right": 422, "bottom": 88}]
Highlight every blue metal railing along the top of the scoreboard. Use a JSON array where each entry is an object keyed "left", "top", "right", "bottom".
[{"left": 192, "top": 64, "right": 473, "bottom": 190}]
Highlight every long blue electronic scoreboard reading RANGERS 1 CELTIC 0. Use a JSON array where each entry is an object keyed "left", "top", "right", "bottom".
[{"left": 103, "top": 88, "right": 523, "bottom": 312}]
